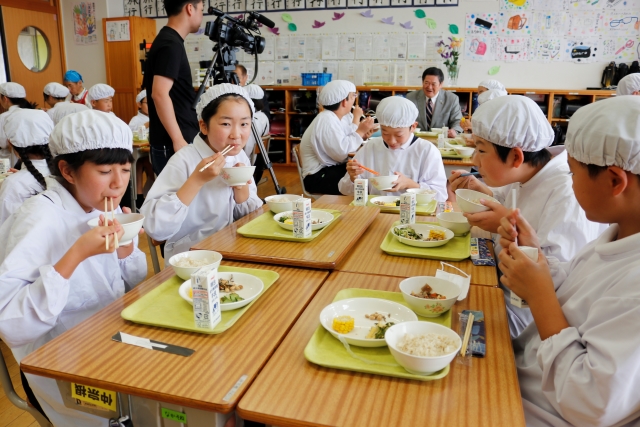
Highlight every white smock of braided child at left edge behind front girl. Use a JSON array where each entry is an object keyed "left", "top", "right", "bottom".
[{"left": 0, "top": 159, "right": 51, "bottom": 225}]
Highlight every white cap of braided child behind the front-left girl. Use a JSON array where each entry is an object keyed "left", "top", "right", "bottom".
[{"left": 3, "top": 108, "right": 53, "bottom": 148}]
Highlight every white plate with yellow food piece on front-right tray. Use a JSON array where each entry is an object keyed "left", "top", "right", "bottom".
[{"left": 320, "top": 298, "right": 418, "bottom": 347}]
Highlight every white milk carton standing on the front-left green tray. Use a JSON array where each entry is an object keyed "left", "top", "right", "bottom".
[{"left": 191, "top": 267, "right": 222, "bottom": 329}]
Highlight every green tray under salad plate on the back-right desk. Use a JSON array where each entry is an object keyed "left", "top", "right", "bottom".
[{"left": 380, "top": 221, "right": 471, "bottom": 261}]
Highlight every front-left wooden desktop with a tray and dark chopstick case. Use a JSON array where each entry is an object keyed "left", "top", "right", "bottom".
[{"left": 21, "top": 262, "right": 328, "bottom": 413}]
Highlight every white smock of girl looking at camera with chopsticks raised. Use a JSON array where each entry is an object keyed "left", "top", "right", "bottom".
[{"left": 141, "top": 135, "right": 262, "bottom": 260}]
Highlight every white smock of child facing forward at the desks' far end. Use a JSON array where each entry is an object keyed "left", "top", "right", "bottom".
[{"left": 338, "top": 135, "right": 448, "bottom": 202}]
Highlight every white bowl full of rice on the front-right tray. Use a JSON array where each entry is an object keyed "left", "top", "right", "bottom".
[{"left": 384, "top": 321, "right": 462, "bottom": 375}]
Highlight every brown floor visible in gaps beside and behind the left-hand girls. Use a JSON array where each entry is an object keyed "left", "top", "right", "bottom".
[{"left": 0, "top": 166, "right": 302, "bottom": 427}]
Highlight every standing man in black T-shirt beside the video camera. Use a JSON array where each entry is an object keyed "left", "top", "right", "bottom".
[{"left": 144, "top": 0, "right": 204, "bottom": 175}]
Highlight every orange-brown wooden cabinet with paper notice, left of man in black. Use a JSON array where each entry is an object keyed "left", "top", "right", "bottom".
[{"left": 102, "top": 16, "right": 156, "bottom": 123}]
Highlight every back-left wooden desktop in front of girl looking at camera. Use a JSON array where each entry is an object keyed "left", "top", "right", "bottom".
[{"left": 191, "top": 202, "right": 380, "bottom": 270}]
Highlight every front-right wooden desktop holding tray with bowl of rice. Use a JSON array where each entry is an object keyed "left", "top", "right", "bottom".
[{"left": 237, "top": 272, "right": 525, "bottom": 427}]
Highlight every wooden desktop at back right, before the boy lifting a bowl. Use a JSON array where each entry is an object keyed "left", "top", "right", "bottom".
[{"left": 316, "top": 196, "right": 499, "bottom": 286}]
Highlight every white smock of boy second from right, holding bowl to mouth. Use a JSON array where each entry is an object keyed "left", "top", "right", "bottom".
[{"left": 493, "top": 151, "right": 607, "bottom": 338}]
